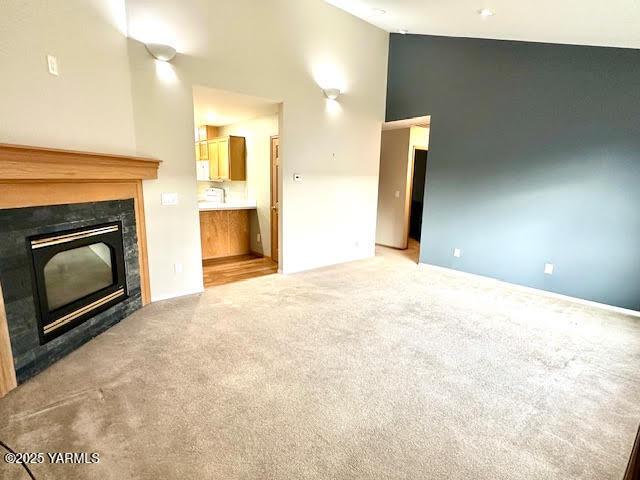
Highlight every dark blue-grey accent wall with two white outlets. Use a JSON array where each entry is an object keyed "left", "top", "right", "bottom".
[{"left": 387, "top": 34, "right": 640, "bottom": 310}]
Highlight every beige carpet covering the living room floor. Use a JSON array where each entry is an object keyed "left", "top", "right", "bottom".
[{"left": 0, "top": 249, "right": 640, "bottom": 480}]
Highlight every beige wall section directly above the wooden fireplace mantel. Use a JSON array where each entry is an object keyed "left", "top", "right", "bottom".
[{"left": 0, "top": 0, "right": 136, "bottom": 154}]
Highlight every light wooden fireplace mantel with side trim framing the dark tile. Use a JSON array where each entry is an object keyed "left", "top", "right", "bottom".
[{"left": 0, "top": 143, "right": 161, "bottom": 398}]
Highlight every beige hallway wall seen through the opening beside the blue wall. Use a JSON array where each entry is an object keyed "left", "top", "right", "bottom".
[{"left": 376, "top": 126, "right": 429, "bottom": 248}]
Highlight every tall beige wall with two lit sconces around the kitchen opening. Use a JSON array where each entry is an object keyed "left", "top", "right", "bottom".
[{"left": 127, "top": 0, "right": 388, "bottom": 299}]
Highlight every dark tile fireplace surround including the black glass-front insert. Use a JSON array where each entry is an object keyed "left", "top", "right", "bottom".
[{"left": 0, "top": 199, "right": 142, "bottom": 383}]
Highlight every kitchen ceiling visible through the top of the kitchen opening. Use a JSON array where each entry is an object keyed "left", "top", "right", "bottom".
[{"left": 193, "top": 85, "right": 279, "bottom": 127}]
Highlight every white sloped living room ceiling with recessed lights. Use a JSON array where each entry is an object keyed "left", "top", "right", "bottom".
[{"left": 326, "top": 0, "right": 640, "bottom": 48}]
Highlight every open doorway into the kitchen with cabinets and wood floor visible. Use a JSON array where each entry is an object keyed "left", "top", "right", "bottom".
[{"left": 193, "top": 86, "right": 280, "bottom": 287}]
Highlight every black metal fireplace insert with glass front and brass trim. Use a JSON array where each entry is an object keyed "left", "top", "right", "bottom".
[{"left": 28, "top": 222, "right": 128, "bottom": 345}]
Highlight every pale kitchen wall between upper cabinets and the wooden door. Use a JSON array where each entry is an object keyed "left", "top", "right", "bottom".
[{"left": 221, "top": 115, "right": 278, "bottom": 256}]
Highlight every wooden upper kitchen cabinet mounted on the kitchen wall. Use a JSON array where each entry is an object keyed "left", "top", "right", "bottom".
[{"left": 207, "top": 135, "right": 247, "bottom": 180}]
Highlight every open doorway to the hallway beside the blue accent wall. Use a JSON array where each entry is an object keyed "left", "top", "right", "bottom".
[{"left": 376, "top": 116, "right": 431, "bottom": 263}]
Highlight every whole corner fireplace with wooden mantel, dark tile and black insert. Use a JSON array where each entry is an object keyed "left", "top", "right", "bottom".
[{"left": 0, "top": 144, "right": 161, "bottom": 397}]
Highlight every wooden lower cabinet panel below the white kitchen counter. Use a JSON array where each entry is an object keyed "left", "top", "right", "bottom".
[{"left": 200, "top": 210, "right": 251, "bottom": 260}]
